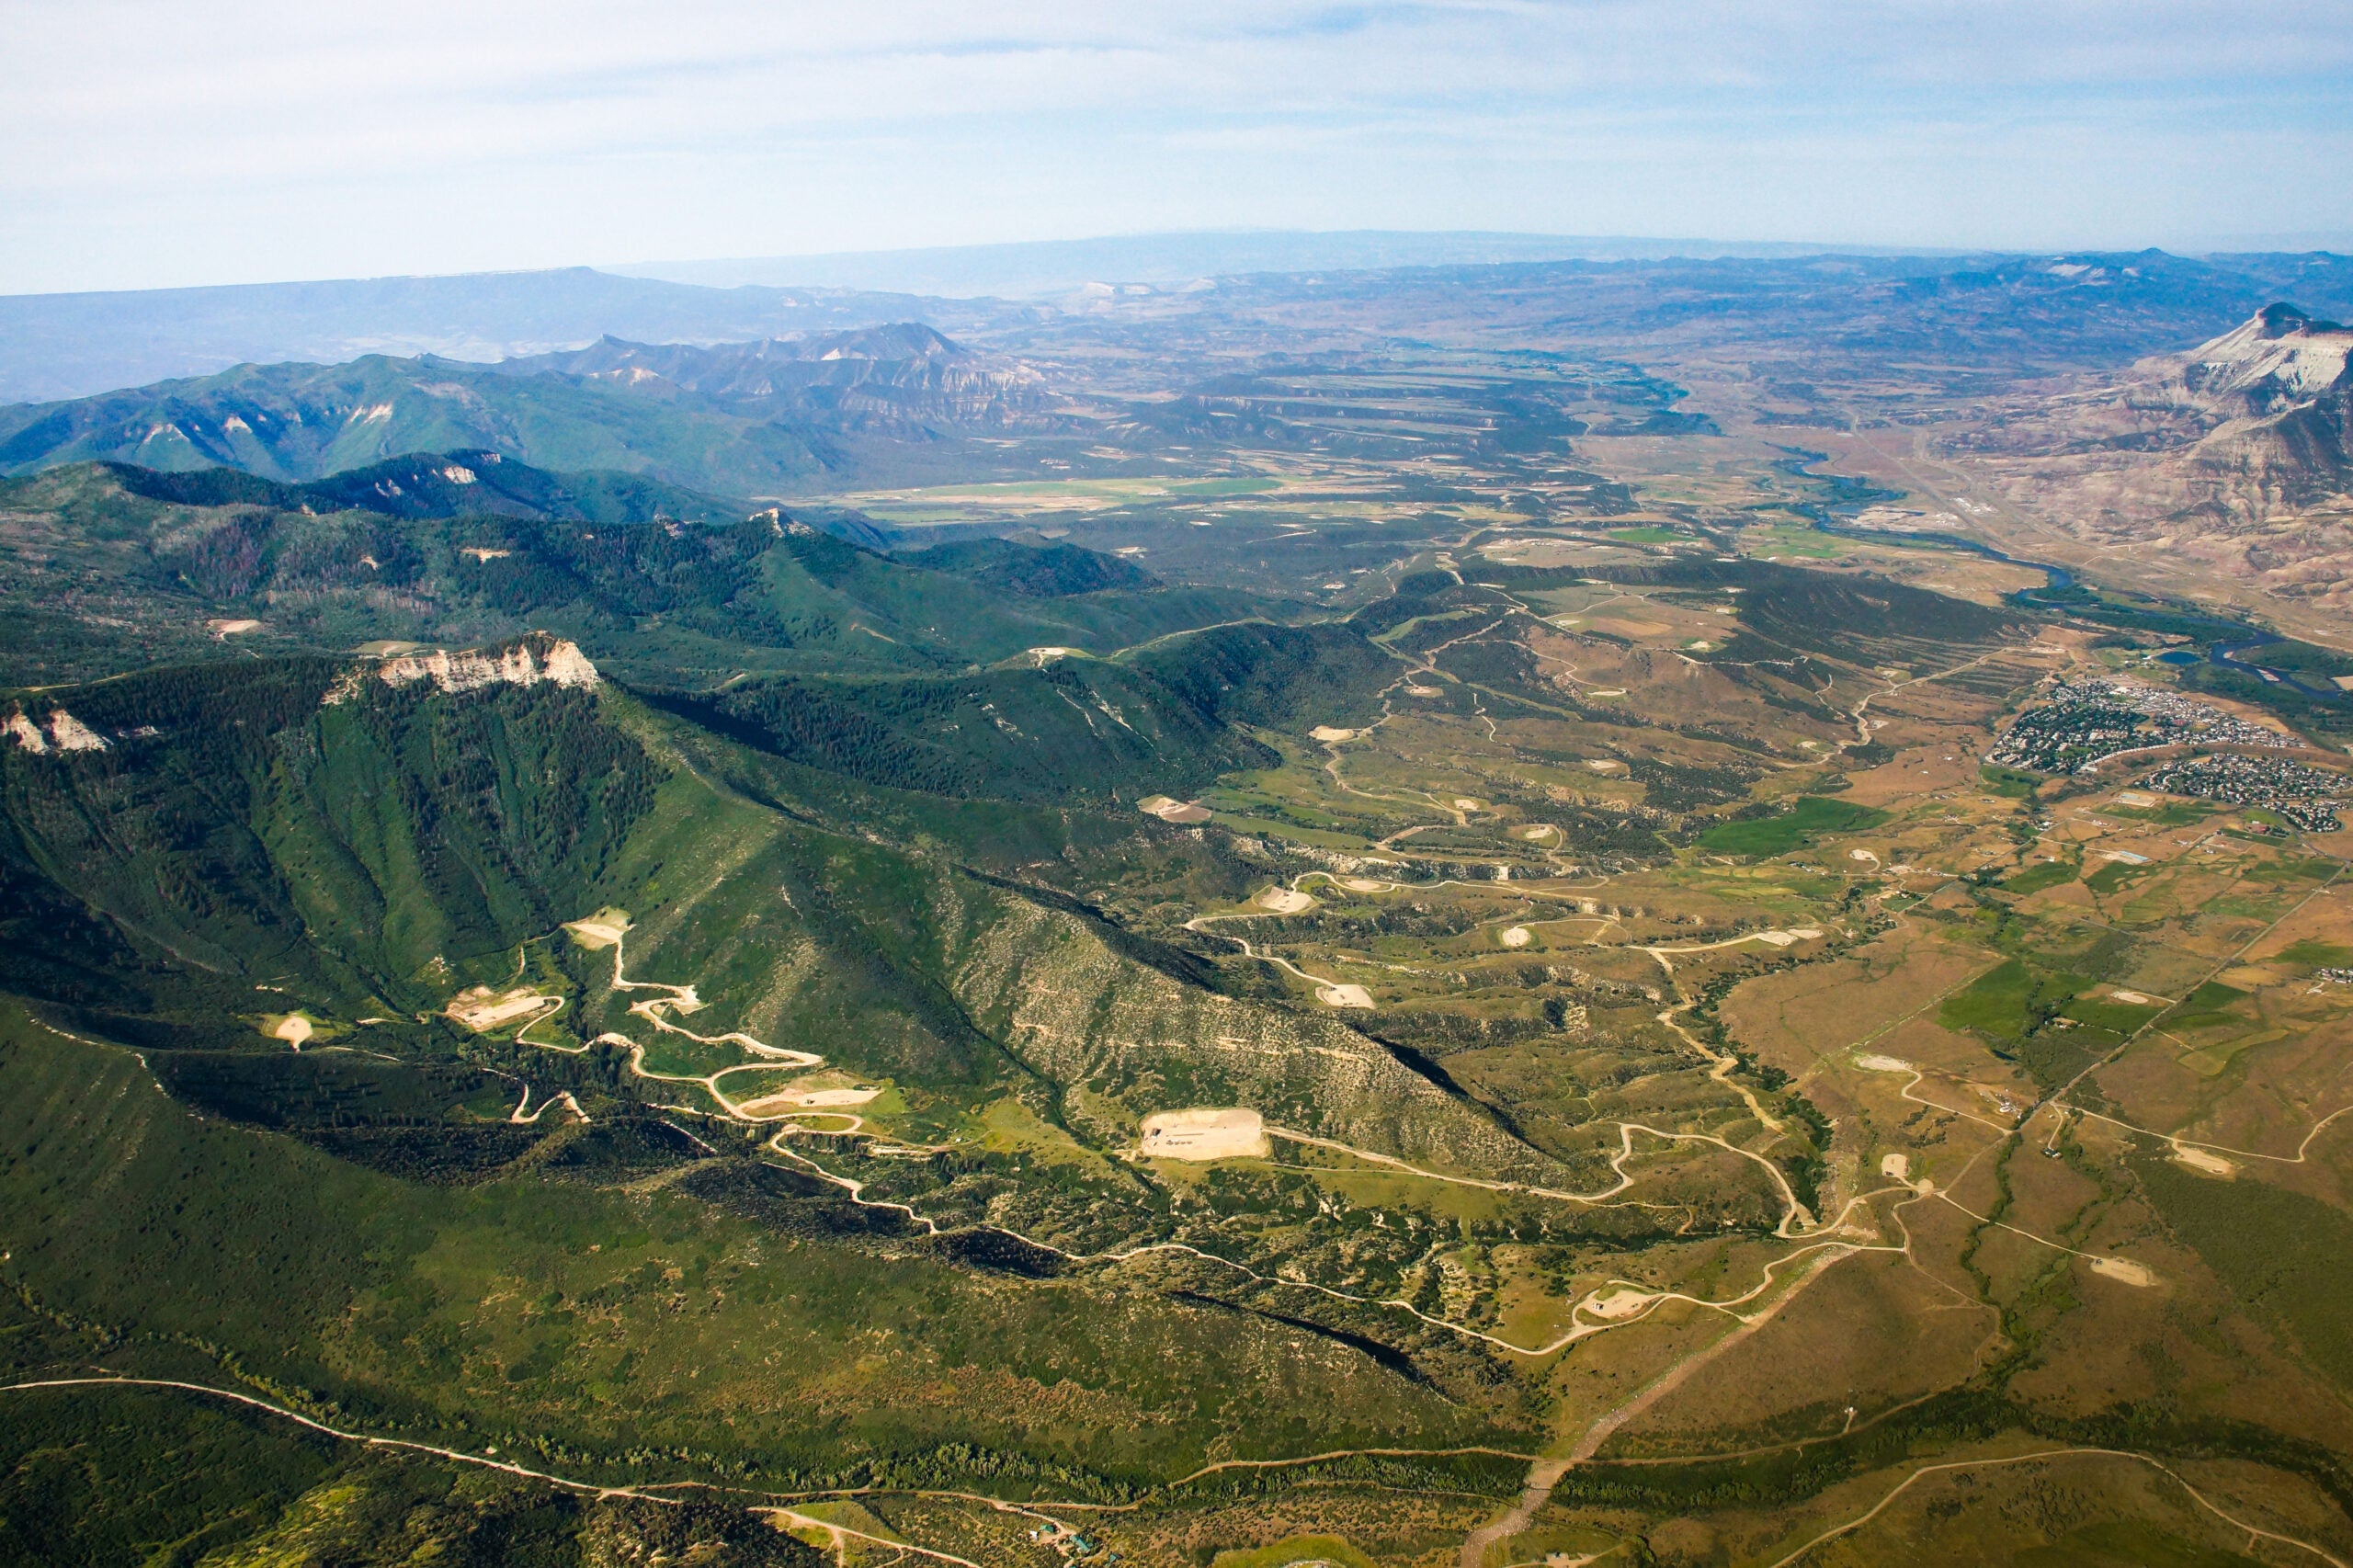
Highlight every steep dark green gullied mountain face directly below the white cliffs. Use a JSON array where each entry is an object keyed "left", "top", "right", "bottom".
[{"left": 0, "top": 644, "right": 661, "bottom": 1036}]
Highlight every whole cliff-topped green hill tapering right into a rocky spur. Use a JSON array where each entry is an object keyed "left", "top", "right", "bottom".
[{"left": 0, "top": 638, "right": 1532, "bottom": 1158}]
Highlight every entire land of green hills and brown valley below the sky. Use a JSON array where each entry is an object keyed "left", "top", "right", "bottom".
[{"left": 0, "top": 252, "right": 2353, "bottom": 1568}]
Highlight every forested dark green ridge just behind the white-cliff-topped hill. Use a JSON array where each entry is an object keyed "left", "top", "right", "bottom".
[{"left": 0, "top": 452, "right": 1266, "bottom": 687}]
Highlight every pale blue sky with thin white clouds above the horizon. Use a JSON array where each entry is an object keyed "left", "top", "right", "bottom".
[{"left": 0, "top": 0, "right": 2353, "bottom": 292}]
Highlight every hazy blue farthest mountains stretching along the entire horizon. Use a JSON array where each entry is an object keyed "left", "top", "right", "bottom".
[{"left": 18, "top": 231, "right": 2353, "bottom": 400}]
